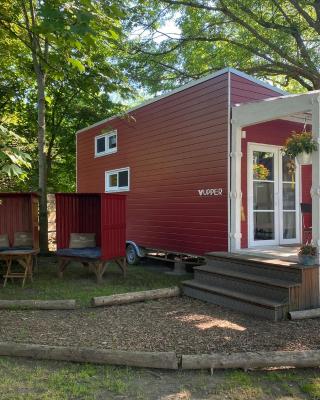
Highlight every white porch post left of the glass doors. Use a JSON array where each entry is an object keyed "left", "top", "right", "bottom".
[{"left": 230, "top": 121, "right": 242, "bottom": 251}]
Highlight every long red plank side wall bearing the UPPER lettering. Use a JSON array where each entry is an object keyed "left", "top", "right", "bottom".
[{"left": 77, "top": 73, "right": 228, "bottom": 254}]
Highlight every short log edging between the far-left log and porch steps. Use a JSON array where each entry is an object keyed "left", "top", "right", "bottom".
[{"left": 91, "top": 286, "right": 180, "bottom": 307}]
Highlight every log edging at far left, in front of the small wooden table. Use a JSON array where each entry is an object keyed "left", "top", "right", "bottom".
[{"left": 0, "top": 300, "right": 76, "bottom": 310}]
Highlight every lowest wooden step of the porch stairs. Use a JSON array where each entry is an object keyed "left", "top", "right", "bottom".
[{"left": 183, "top": 280, "right": 289, "bottom": 321}]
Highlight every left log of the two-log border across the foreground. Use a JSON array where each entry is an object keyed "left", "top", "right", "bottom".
[{"left": 0, "top": 342, "right": 179, "bottom": 369}]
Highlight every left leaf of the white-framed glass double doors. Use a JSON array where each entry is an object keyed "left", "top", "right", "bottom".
[{"left": 248, "top": 145, "right": 279, "bottom": 246}]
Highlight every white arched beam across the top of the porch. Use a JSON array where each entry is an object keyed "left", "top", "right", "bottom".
[{"left": 231, "top": 90, "right": 320, "bottom": 127}]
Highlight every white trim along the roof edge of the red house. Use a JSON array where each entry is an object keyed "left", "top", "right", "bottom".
[{"left": 76, "top": 67, "right": 287, "bottom": 134}]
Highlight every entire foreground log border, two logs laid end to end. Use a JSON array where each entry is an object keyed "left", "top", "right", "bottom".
[{"left": 0, "top": 342, "right": 320, "bottom": 370}]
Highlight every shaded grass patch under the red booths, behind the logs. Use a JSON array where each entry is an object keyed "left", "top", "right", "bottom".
[{"left": 0, "top": 257, "right": 186, "bottom": 306}]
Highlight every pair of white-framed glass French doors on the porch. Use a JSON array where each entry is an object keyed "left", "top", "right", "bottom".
[{"left": 248, "top": 144, "right": 300, "bottom": 246}]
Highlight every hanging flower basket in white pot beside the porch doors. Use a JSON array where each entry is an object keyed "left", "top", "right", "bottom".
[{"left": 282, "top": 132, "right": 318, "bottom": 165}]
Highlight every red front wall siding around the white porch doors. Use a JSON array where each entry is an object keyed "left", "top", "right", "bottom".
[{"left": 241, "top": 120, "right": 311, "bottom": 248}]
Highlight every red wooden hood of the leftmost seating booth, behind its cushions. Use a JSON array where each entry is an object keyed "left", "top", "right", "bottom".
[{"left": 0, "top": 193, "right": 39, "bottom": 249}]
